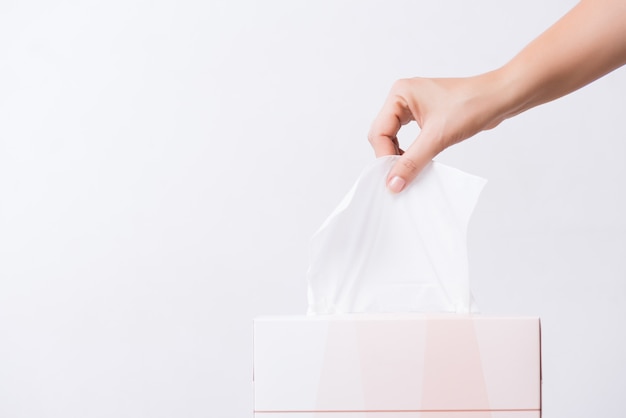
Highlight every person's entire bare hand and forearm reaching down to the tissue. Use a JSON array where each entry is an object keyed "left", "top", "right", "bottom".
[{"left": 368, "top": 0, "right": 626, "bottom": 193}]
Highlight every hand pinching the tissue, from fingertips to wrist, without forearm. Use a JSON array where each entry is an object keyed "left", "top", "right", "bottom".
[{"left": 368, "top": 72, "right": 503, "bottom": 193}]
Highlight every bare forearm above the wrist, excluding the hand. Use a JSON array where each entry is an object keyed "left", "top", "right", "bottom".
[{"left": 490, "top": 0, "right": 626, "bottom": 120}]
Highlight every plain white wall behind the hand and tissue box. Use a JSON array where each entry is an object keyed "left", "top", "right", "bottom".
[{"left": 0, "top": 0, "right": 626, "bottom": 418}]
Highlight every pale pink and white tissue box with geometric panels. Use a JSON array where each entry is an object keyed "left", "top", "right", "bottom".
[{"left": 253, "top": 314, "right": 541, "bottom": 418}]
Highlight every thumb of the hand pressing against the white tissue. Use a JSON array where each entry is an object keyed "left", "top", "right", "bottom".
[{"left": 387, "top": 130, "right": 443, "bottom": 193}]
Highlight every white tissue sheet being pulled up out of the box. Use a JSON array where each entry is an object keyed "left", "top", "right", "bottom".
[{"left": 307, "top": 156, "right": 486, "bottom": 314}]
